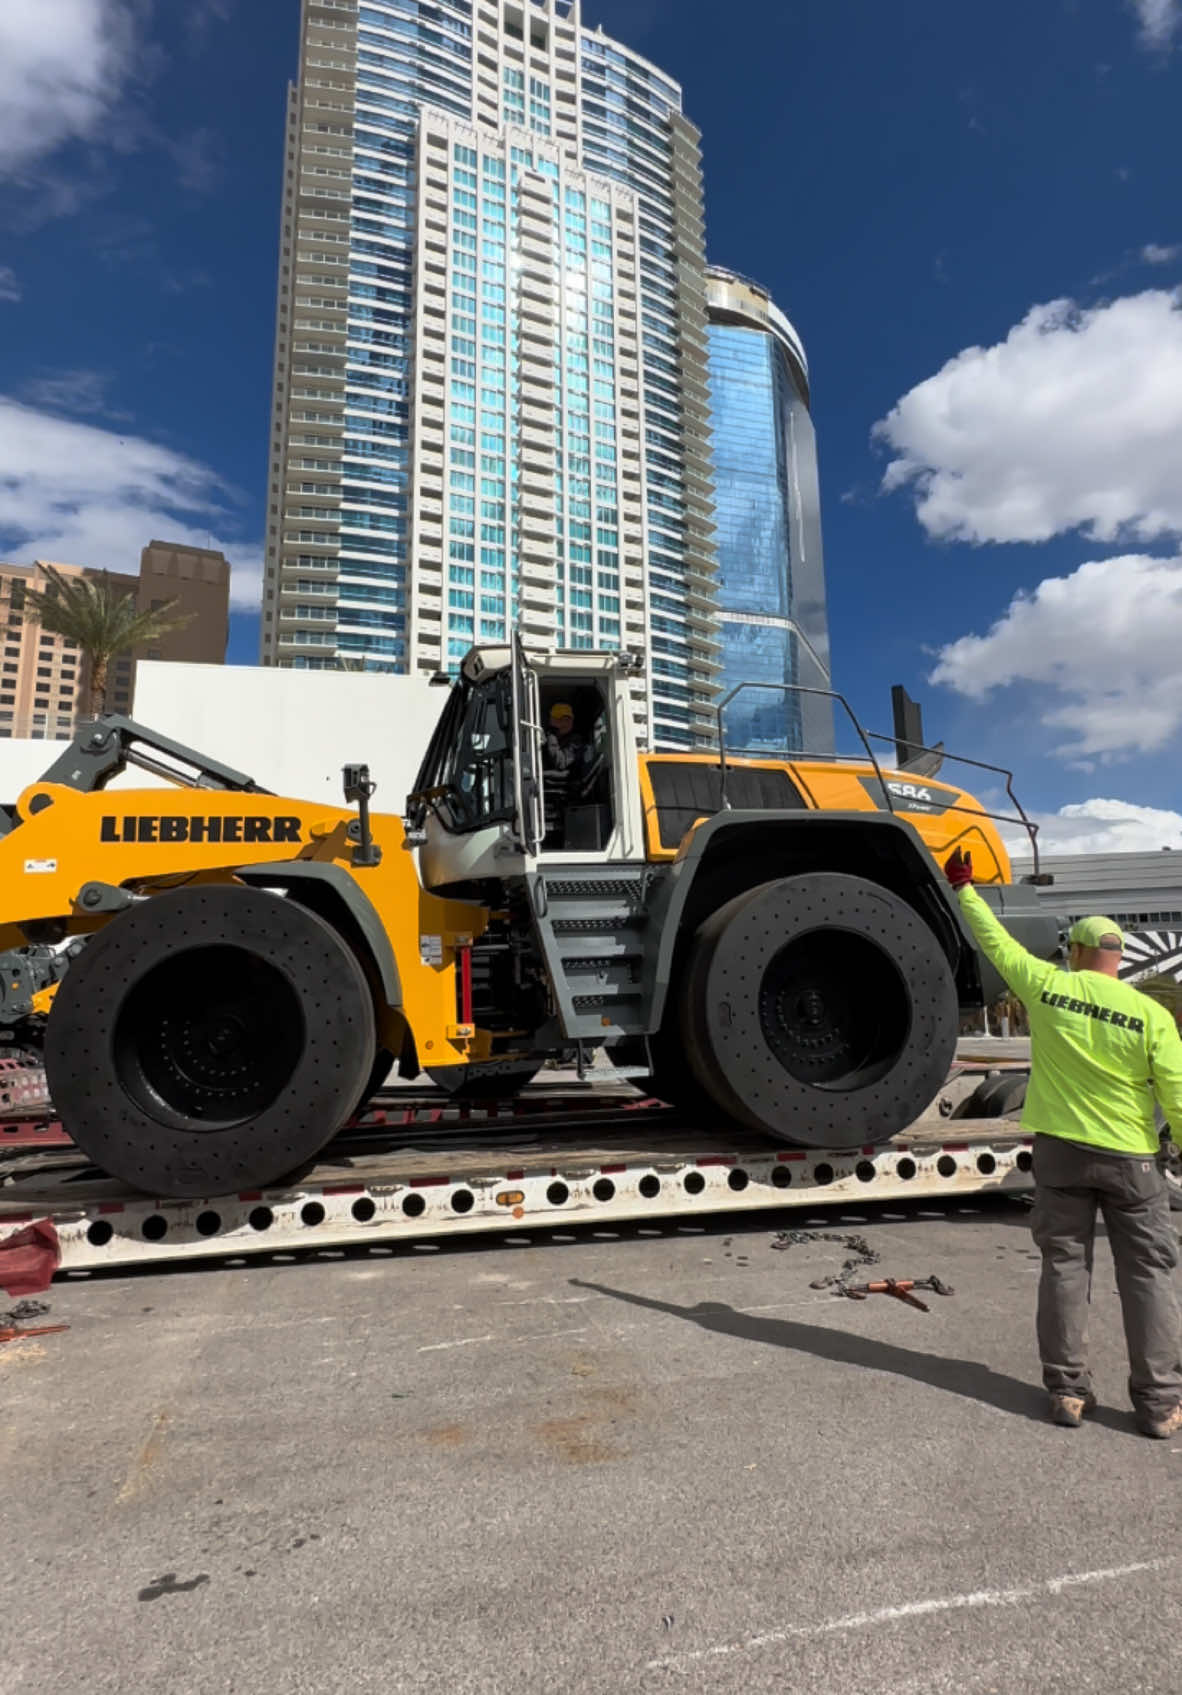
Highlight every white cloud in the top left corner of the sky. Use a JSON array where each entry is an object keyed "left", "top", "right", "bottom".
[{"left": 0, "top": 0, "right": 139, "bottom": 180}]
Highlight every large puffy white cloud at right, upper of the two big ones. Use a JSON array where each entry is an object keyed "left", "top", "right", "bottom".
[{"left": 873, "top": 290, "right": 1182, "bottom": 542}]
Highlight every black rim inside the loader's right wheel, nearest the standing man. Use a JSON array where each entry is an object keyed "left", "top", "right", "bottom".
[{"left": 760, "top": 929, "right": 911, "bottom": 1092}]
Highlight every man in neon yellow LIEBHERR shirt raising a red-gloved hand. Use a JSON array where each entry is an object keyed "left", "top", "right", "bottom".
[{"left": 945, "top": 849, "right": 1182, "bottom": 1437}]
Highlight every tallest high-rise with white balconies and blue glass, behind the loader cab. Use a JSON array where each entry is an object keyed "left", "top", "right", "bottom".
[{"left": 263, "top": 0, "right": 719, "bottom": 747}]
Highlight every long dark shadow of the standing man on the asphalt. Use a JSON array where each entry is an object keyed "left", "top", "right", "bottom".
[{"left": 568, "top": 1278, "right": 1135, "bottom": 1436}]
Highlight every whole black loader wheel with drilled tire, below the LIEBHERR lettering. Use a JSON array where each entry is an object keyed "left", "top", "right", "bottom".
[{"left": 46, "top": 885, "right": 375, "bottom": 1198}]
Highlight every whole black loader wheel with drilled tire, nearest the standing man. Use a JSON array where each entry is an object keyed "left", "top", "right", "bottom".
[{"left": 680, "top": 871, "right": 958, "bottom": 1148}]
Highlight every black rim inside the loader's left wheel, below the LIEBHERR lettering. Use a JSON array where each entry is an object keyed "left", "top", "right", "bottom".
[{"left": 114, "top": 946, "right": 304, "bottom": 1131}]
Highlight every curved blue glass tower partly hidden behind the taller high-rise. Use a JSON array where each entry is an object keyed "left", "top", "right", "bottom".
[{"left": 709, "top": 271, "right": 833, "bottom": 753}]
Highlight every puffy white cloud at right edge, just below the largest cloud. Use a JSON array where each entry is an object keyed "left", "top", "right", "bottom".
[{"left": 929, "top": 554, "right": 1182, "bottom": 763}]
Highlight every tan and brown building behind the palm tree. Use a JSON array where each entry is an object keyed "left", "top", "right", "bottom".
[{"left": 0, "top": 541, "right": 231, "bottom": 741}]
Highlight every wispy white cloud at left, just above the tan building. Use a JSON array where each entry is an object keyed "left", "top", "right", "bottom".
[{"left": 0, "top": 395, "right": 261, "bottom": 610}]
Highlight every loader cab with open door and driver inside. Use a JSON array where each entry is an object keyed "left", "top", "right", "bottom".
[{"left": 407, "top": 639, "right": 643, "bottom": 890}]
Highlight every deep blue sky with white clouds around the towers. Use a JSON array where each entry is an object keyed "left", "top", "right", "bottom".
[{"left": 0, "top": 0, "right": 1182, "bottom": 846}]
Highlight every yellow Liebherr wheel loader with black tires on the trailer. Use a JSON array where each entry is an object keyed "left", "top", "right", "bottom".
[{"left": 0, "top": 639, "right": 1058, "bottom": 1197}]
